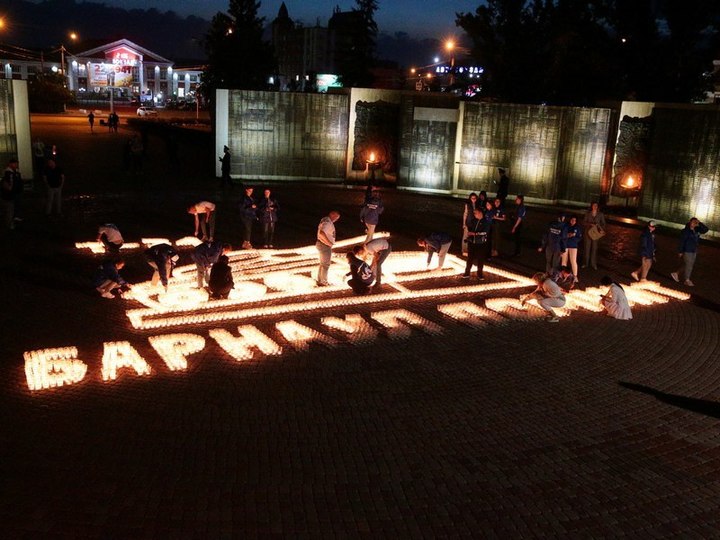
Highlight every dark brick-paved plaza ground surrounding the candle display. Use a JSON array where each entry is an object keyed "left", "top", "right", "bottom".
[{"left": 0, "top": 117, "right": 720, "bottom": 539}]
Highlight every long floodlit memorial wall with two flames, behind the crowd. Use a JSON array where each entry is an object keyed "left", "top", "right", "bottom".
[{"left": 216, "top": 89, "right": 720, "bottom": 229}]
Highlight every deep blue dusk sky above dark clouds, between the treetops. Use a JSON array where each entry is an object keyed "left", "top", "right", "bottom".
[{"left": 93, "top": 0, "right": 484, "bottom": 38}]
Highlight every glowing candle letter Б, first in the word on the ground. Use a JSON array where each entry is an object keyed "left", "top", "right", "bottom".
[{"left": 24, "top": 347, "right": 87, "bottom": 390}]
